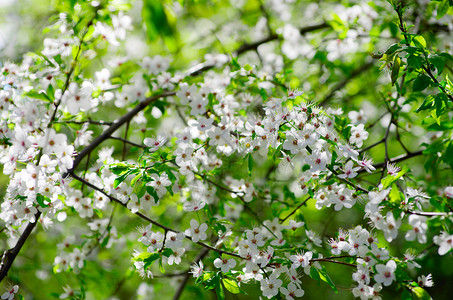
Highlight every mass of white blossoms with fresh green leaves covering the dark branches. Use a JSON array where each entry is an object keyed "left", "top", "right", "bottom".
[{"left": 0, "top": 1, "right": 453, "bottom": 300}]
